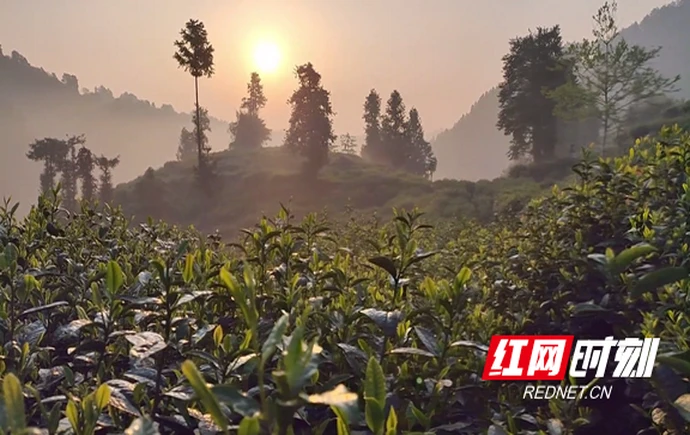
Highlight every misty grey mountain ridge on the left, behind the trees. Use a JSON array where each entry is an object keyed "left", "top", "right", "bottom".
[{"left": 0, "top": 49, "right": 231, "bottom": 215}]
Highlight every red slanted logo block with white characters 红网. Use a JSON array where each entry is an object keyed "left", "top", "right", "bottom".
[{"left": 482, "top": 335, "right": 575, "bottom": 381}]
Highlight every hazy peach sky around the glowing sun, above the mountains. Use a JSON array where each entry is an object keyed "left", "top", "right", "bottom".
[{"left": 0, "top": 0, "right": 670, "bottom": 135}]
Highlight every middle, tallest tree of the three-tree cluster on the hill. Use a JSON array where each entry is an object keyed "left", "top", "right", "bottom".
[{"left": 381, "top": 90, "right": 410, "bottom": 169}]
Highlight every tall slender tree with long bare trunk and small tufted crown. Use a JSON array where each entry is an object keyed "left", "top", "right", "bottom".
[{"left": 174, "top": 20, "right": 214, "bottom": 177}]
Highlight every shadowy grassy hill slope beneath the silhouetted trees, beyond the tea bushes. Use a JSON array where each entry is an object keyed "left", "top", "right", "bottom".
[{"left": 111, "top": 148, "right": 553, "bottom": 240}]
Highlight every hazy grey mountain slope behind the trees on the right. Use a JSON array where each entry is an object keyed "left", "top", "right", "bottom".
[{"left": 432, "top": 0, "right": 690, "bottom": 181}]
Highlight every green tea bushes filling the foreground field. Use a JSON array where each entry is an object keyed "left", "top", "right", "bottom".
[{"left": 0, "top": 129, "right": 690, "bottom": 435}]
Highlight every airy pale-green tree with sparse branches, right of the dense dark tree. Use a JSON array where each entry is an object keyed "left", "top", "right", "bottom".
[{"left": 550, "top": 1, "right": 680, "bottom": 155}]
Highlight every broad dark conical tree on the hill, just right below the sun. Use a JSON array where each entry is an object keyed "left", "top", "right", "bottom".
[{"left": 284, "top": 63, "right": 336, "bottom": 176}]
